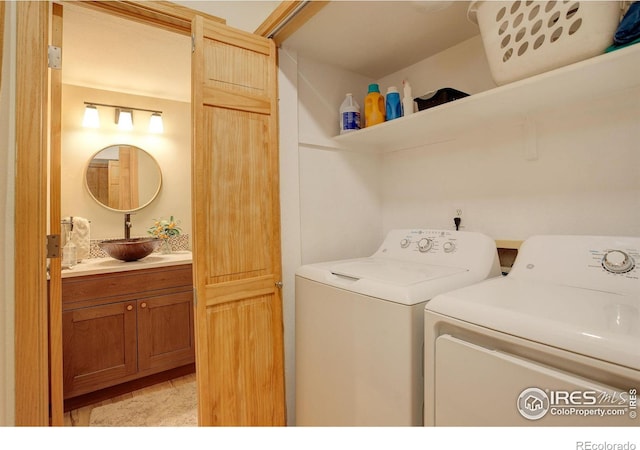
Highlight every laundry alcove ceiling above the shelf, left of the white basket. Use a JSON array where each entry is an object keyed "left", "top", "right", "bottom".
[{"left": 283, "top": 0, "right": 480, "bottom": 79}]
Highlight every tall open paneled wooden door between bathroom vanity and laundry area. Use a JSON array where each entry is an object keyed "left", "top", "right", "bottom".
[{"left": 192, "top": 16, "right": 285, "bottom": 426}]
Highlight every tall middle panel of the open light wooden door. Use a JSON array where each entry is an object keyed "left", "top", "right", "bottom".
[{"left": 205, "top": 107, "right": 273, "bottom": 282}]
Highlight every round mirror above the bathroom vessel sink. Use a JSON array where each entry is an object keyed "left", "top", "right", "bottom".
[{"left": 84, "top": 144, "right": 162, "bottom": 211}]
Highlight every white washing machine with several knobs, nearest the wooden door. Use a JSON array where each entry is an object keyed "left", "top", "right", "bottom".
[{"left": 296, "top": 230, "right": 500, "bottom": 426}]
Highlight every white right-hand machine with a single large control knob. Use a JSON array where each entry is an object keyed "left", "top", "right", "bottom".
[{"left": 425, "top": 236, "right": 640, "bottom": 426}]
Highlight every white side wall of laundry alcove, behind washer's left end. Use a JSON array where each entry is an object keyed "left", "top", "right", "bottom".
[{"left": 298, "top": 57, "right": 382, "bottom": 264}]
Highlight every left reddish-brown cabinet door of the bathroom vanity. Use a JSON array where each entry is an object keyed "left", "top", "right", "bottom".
[{"left": 62, "top": 302, "right": 137, "bottom": 398}]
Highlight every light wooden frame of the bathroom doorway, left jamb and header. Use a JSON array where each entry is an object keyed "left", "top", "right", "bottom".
[{"left": 14, "top": 0, "right": 316, "bottom": 426}]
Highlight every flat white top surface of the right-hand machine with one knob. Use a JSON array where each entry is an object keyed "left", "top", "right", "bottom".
[{"left": 426, "top": 276, "right": 640, "bottom": 370}]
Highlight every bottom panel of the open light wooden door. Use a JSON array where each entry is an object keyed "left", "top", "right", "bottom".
[{"left": 207, "top": 295, "right": 284, "bottom": 426}]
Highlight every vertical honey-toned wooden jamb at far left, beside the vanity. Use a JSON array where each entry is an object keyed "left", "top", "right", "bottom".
[{"left": 14, "top": 2, "right": 63, "bottom": 426}]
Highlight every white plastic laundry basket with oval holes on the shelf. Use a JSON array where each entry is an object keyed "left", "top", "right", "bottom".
[{"left": 467, "top": 0, "right": 624, "bottom": 85}]
